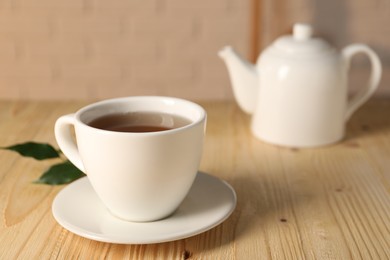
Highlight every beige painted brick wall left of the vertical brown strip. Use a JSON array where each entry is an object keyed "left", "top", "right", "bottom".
[{"left": 0, "top": 0, "right": 250, "bottom": 99}]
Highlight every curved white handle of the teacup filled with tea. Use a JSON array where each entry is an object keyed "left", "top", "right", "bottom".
[{"left": 54, "top": 114, "right": 85, "bottom": 173}]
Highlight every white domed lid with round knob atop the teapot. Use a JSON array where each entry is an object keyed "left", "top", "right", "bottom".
[{"left": 273, "top": 23, "right": 332, "bottom": 54}]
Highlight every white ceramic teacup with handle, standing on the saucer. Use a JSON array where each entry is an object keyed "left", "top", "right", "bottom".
[{"left": 55, "top": 96, "right": 206, "bottom": 221}]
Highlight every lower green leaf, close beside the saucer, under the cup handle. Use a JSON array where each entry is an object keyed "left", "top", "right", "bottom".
[{"left": 34, "top": 161, "right": 85, "bottom": 185}]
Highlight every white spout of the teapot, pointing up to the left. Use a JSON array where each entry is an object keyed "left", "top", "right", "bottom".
[{"left": 218, "top": 46, "right": 259, "bottom": 114}]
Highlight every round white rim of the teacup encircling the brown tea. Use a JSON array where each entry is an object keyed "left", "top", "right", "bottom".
[{"left": 74, "top": 96, "right": 207, "bottom": 136}]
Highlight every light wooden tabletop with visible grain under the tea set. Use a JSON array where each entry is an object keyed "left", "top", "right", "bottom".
[{"left": 0, "top": 100, "right": 390, "bottom": 259}]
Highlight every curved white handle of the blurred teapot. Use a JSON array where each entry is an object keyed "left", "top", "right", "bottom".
[{"left": 342, "top": 44, "right": 382, "bottom": 121}]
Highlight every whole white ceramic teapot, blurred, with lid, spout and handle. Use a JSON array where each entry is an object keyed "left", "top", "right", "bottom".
[{"left": 218, "top": 24, "right": 382, "bottom": 147}]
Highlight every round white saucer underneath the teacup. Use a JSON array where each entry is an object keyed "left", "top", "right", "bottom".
[{"left": 52, "top": 172, "right": 237, "bottom": 244}]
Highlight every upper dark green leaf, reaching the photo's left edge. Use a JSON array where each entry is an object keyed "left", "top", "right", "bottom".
[{"left": 2, "top": 142, "right": 60, "bottom": 160}]
